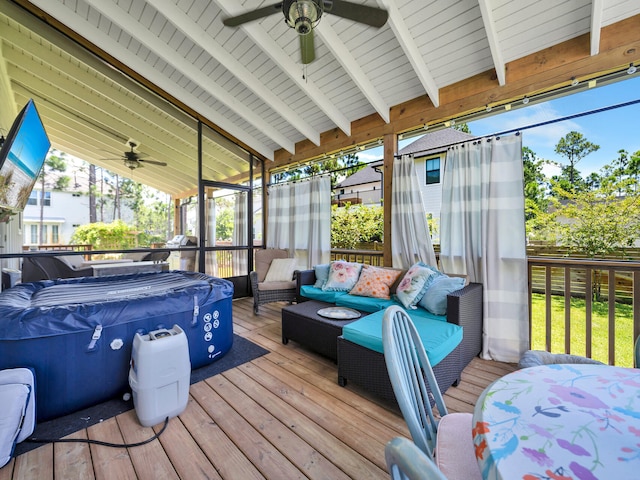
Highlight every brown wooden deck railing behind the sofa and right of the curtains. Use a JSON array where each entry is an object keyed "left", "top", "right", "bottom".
[{"left": 331, "top": 249, "right": 640, "bottom": 367}]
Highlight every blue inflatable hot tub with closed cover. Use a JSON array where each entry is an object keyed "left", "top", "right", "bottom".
[{"left": 0, "top": 271, "right": 233, "bottom": 421}]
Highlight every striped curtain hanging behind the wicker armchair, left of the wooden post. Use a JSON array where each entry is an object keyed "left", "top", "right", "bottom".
[{"left": 266, "top": 175, "right": 331, "bottom": 268}]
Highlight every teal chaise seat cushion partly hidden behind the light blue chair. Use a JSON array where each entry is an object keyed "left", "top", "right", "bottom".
[{"left": 342, "top": 310, "right": 462, "bottom": 367}]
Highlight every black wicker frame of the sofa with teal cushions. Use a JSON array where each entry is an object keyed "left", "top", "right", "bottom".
[{"left": 296, "top": 269, "right": 483, "bottom": 402}]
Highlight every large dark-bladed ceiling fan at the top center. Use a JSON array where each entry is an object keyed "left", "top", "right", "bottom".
[{"left": 222, "top": 0, "right": 389, "bottom": 65}]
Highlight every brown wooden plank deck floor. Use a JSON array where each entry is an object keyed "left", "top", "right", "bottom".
[{"left": 0, "top": 299, "right": 514, "bottom": 480}]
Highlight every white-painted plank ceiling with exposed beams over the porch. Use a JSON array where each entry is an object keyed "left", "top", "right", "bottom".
[{"left": 0, "top": 0, "right": 640, "bottom": 196}]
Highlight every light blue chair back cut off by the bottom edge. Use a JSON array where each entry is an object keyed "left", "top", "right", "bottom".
[{"left": 384, "top": 437, "right": 447, "bottom": 480}]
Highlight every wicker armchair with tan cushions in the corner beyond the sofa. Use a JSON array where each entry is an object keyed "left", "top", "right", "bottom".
[{"left": 249, "top": 248, "right": 296, "bottom": 314}]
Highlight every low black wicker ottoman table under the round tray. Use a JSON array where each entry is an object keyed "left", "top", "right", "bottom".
[{"left": 282, "top": 300, "right": 366, "bottom": 362}]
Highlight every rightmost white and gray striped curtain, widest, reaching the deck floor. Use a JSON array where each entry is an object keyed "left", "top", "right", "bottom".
[{"left": 440, "top": 134, "right": 529, "bottom": 362}]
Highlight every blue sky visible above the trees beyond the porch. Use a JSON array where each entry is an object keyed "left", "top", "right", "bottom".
[{"left": 358, "top": 71, "right": 640, "bottom": 177}]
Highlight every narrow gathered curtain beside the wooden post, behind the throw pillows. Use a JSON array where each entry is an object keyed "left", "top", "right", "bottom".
[{"left": 391, "top": 155, "right": 436, "bottom": 269}]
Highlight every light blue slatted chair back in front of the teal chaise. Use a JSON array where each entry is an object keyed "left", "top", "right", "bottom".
[{"left": 382, "top": 305, "right": 448, "bottom": 459}]
